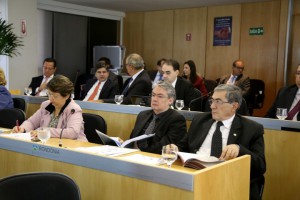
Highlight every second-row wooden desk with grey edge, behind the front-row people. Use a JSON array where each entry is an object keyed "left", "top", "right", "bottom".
[{"left": 7, "top": 95, "right": 300, "bottom": 200}]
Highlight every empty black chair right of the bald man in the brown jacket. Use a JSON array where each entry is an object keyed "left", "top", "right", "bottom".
[{"left": 248, "top": 79, "right": 265, "bottom": 116}]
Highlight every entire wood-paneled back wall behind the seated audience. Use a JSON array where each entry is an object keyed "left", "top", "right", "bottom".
[{"left": 124, "top": 0, "right": 290, "bottom": 116}]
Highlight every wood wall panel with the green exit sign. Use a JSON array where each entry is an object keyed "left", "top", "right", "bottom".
[{"left": 240, "top": 1, "right": 283, "bottom": 116}]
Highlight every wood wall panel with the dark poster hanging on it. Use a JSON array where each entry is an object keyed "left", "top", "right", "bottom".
[{"left": 205, "top": 5, "right": 241, "bottom": 79}]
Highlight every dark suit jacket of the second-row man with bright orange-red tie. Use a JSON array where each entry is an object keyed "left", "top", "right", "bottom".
[{"left": 81, "top": 78, "right": 118, "bottom": 102}]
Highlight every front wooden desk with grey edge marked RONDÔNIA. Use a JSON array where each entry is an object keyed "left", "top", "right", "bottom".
[{"left": 0, "top": 137, "right": 250, "bottom": 200}]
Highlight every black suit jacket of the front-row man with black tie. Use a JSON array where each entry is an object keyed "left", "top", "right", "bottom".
[{"left": 178, "top": 113, "right": 266, "bottom": 199}]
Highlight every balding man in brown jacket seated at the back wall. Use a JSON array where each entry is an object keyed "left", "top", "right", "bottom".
[{"left": 219, "top": 60, "right": 250, "bottom": 102}]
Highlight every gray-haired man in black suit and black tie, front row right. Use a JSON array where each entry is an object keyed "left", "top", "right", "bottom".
[{"left": 177, "top": 84, "right": 266, "bottom": 200}]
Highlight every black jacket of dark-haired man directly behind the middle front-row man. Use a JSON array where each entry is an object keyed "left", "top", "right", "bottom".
[{"left": 175, "top": 77, "right": 198, "bottom": 110}]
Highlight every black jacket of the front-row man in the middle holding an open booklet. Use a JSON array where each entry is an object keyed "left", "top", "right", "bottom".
[{"left": 130, "top": 109, "right": 186, "bottom": 154}]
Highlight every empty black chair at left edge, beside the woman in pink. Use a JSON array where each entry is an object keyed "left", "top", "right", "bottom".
[{"left": 0, "top": 108, "right": 25, "bottom": 129}]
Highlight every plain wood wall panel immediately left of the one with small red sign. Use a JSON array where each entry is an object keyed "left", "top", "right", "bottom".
[{"left": 143, "top": 10, "right": 174, "bottom": 69}]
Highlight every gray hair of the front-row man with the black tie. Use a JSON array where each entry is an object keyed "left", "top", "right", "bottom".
[{"left": 214, "top": 84, "right": 243, "bottom": 105}]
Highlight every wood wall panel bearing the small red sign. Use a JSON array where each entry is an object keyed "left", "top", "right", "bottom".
[{"left": 173, "top": 7, "right": 207, "bottom": 75}]
